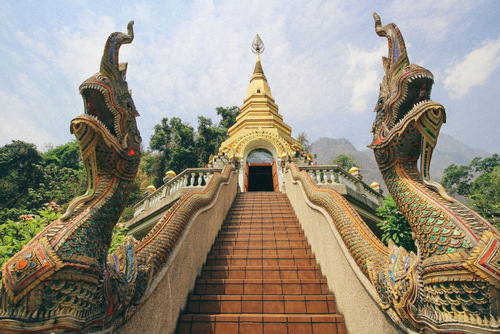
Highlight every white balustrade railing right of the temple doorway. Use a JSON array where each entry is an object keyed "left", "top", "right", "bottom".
[{"left": 299, "top": 165, "right": 384, "bottom": 204}]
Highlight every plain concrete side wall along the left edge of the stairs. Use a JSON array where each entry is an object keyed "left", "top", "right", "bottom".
[{"left": 114, "top": 171, "right": 238, "bottom": 334}]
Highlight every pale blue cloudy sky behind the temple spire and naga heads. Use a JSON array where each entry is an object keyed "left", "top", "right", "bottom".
[{"left": 0, "top": 0, "right": 500, "bottom": 153}]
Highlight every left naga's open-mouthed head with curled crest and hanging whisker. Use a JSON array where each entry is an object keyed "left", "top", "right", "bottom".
[{"left": 61, "top": 21, "right": 142, "bottom": 220}]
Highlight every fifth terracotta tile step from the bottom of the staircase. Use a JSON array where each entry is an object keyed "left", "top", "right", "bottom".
[{"left": 206, "top": 255, "right": 316, "bottom": 266}]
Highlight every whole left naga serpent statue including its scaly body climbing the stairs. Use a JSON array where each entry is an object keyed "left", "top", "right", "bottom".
[{"left": 0, "top": 21, "right": 234, "bottom": 333}]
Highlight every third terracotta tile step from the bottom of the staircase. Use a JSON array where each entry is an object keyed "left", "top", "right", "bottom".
[{"left": 195, "top": 278, "right": 328, "bottom": 295}]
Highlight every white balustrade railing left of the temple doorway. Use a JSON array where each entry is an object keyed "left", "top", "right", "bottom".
[{"left": 134, "top": 168, "right": 222, "bottom": 217}]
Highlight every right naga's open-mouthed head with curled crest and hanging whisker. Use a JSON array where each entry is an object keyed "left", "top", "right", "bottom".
[{"left": 369, "top": 13, "right": 452, "bottom": 201}]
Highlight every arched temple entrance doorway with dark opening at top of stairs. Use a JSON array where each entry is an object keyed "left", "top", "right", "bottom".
[{"left": 244, "top": 148, "right": 279, "bottom": 191}]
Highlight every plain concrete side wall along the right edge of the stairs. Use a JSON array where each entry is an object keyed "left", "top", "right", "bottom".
[{"left": 284, "top": 170, "right": 400, "bottom": 334}]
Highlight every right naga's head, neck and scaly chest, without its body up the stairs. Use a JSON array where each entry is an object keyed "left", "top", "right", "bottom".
[{"left": 369, "top": 13, "right": 500, "bottom": 333}]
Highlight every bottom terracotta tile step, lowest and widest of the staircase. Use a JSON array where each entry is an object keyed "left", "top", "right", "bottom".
[{"left": 177, "top": 314, "right": 346, "bottom": 334}]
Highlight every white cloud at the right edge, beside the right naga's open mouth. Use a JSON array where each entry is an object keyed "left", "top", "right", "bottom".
[{"left": 444, "top": 38, "right": 500, "bottom": 99}]
